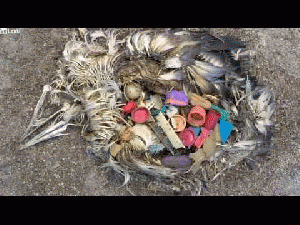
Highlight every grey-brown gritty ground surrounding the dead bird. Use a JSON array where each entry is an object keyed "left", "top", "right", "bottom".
[{"left": 0, "top": 28, "right": 300, "bottom": 196}]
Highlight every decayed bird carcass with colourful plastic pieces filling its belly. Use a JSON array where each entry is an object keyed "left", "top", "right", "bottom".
[{"left": 21, "top": 28, "right": 274, "bottom": 194}]
